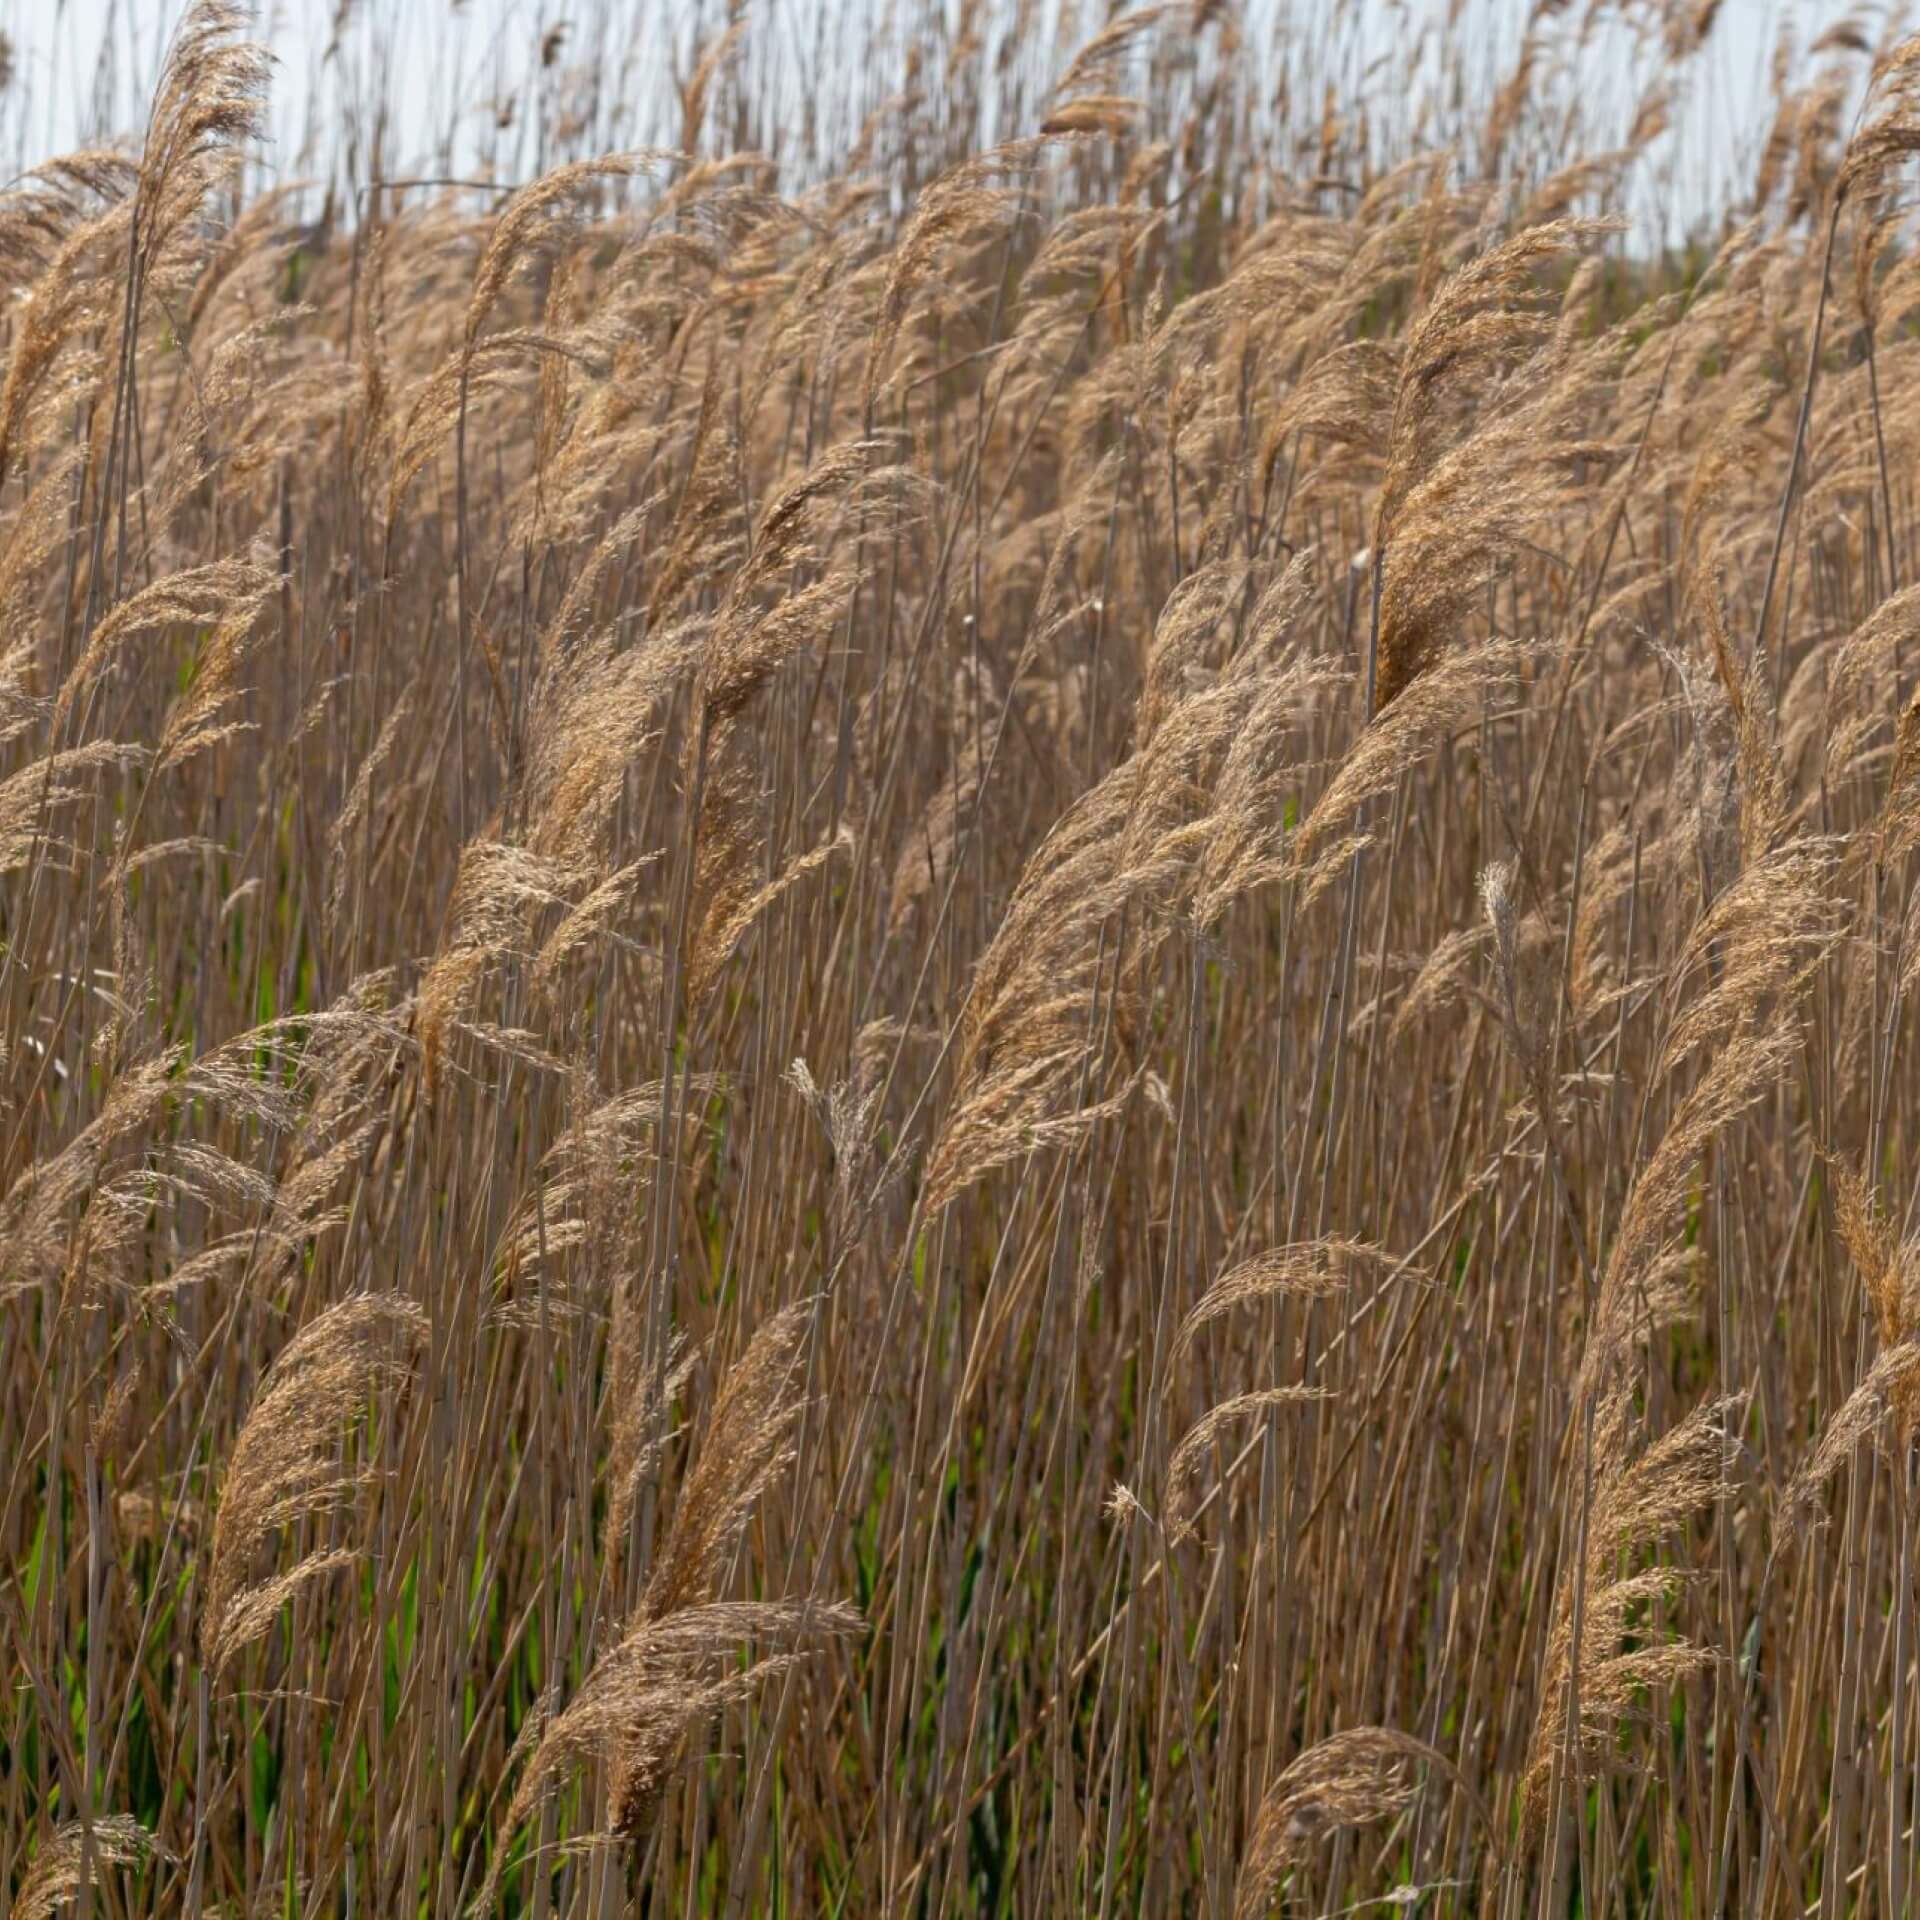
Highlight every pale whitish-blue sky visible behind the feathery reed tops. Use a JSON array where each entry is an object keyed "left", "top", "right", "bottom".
[{"left": 0, "top": 0, "right": 1873, "bottom": 243}]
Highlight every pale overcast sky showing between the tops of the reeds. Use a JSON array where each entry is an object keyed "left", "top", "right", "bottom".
[{"left": 0, "top": 0, "right": 1873, "bottom": 238}]
